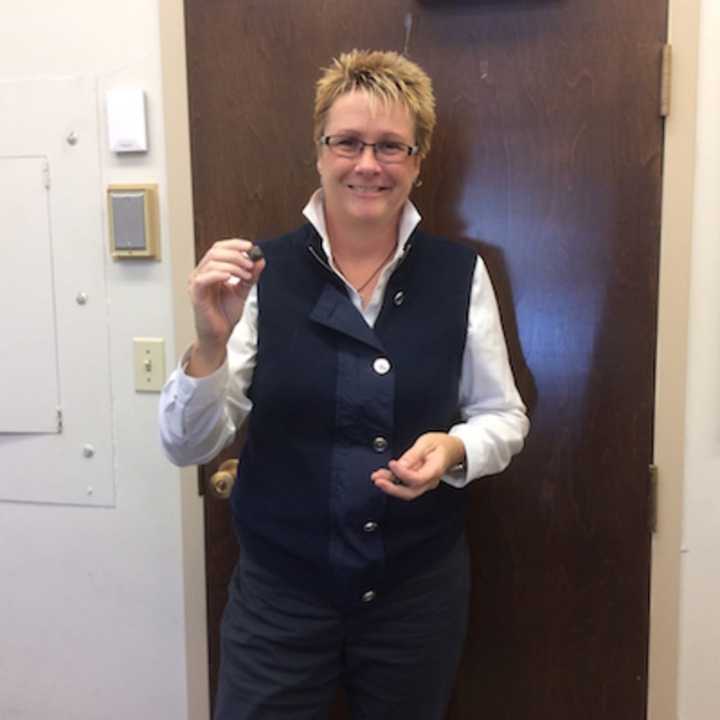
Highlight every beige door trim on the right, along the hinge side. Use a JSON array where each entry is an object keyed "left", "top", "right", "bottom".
[{"left": 648, "top": 0, "right": 701, "bottom": 720}]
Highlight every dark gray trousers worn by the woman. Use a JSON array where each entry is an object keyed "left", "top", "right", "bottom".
[{"left": 215, "top": 537, "right": 470, "bottom": 720}]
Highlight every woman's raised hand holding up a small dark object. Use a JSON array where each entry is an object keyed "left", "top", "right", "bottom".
[{"left": 186, "top": 238, "right": 265, "bottom": 377}]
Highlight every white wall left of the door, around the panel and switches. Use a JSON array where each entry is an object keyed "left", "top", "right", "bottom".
[{"left": 0, "top": 0, "right": 204, "bottom": 720}]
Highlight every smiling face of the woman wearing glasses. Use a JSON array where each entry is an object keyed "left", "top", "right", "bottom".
[{"left": 317, "top": 90, "right": 420, "bottom": 232}]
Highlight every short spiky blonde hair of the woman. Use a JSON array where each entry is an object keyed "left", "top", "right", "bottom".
[{"left": 313, "top": 50, "right": 435, "bottom": 158}]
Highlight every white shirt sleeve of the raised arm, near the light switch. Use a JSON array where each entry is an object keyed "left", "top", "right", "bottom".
[{"left": 159, "top": 288, "right": 258, "bottom": 465}]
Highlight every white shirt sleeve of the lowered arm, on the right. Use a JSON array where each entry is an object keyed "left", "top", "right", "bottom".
[{"left": 443, "top": 257, "right": 530, "bottom": 487}]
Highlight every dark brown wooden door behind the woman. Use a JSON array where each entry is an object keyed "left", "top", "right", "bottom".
[{"left": 186, "top": 0, "right": 666, "bottom": 720}]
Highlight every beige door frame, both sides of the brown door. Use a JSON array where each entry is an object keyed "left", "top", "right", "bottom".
[{"left": 158, "top": 0, "right": 701, "bottom": 720}]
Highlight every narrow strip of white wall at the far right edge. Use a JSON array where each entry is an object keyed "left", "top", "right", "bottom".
[{"left": 679, "top": 0, "right": 720, "bottom": 720}]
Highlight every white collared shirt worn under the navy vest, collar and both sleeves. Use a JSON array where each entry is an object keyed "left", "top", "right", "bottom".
[{"left": 160, "top": 190, "right": 529, "bottom": 487}]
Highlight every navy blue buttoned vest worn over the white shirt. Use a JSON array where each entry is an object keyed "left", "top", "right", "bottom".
[{"left": 231, "top": 225, "right": 475, "bottom": 607}]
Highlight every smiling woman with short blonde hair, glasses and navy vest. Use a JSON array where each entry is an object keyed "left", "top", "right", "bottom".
[{"left": 161, "top": 51, "right": 528, "bottom": 720}]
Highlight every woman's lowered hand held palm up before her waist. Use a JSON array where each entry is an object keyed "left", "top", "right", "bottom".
[{"left": 370, "top": 433, "right": 465, "bottom": 500}]
